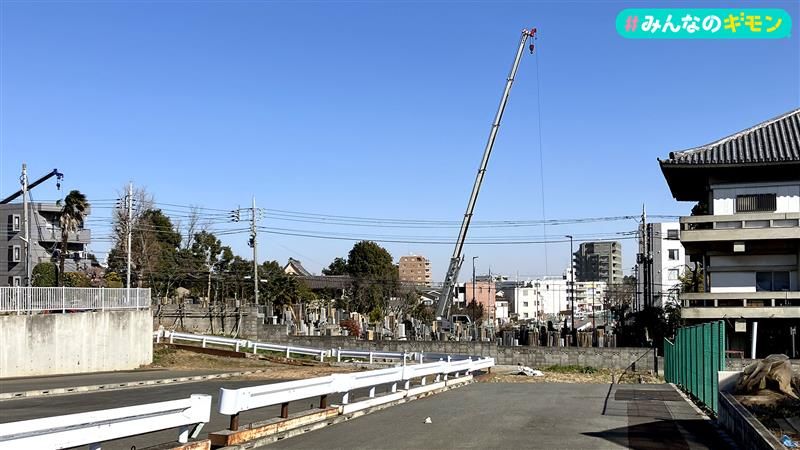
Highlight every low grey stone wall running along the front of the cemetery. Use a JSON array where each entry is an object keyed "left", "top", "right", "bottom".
[{"left": 270, "top": 336, "right": 653, "bottom": 371}]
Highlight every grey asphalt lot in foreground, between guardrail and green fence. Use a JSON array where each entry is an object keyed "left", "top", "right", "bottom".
[{"left": 264, "top": 383, "right": 727, "bottom": 449}]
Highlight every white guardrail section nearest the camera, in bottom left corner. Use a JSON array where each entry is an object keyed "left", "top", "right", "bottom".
[{"left": 0, "top": 395, "right": 211, "bottom": 450}]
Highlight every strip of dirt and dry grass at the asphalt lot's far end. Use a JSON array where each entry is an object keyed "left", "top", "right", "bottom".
[{"left": 478, "top": 366, "right": 664, "bottom": 384}]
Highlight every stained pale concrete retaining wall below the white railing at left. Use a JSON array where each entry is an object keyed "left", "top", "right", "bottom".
[{"left": 0, "top": 310, "right": 153, "bottom": 378}]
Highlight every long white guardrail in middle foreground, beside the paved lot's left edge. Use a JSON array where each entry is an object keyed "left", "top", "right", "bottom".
[{"left": 219, "top": 358, "right": 494, "bottom": 431}]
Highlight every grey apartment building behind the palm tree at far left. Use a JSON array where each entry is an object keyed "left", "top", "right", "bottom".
[{"left": 0, "top": 203, "right": 92, "bottom": 286}]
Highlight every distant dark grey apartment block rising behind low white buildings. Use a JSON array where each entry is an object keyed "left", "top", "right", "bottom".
[{"left": 574, "top": 241, "right": 622, "bottom": 284}]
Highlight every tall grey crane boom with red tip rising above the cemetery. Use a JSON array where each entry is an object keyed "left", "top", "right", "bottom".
[{"left": 436, "top": 28, "right": 536, "bottom": 320}]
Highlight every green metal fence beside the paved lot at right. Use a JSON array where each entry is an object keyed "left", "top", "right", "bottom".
[{"left": 664, "top": 321, "right": 725, "bottom": 414}]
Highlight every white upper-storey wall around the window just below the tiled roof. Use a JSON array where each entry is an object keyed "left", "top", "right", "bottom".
[{"left": 711, "top": 183, "right": 800, "bottom": 216}]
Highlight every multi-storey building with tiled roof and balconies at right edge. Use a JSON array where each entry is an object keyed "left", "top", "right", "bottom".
[{"left": 659, "top": 109, "right": 800, "bottom": 357}]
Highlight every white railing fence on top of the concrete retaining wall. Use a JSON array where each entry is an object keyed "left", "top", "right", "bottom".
[{"left": 0, "top": 287, "right": 150, "bottom": 314}]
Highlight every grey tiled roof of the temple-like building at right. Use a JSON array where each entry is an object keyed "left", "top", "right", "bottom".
[{"left": 659, "top": 108, "right": 800, "bottom": 166}]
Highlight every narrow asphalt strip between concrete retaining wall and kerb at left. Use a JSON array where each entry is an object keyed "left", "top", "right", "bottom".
[{"left": 0, "top": 369, "right": 231, "bottom": 392}]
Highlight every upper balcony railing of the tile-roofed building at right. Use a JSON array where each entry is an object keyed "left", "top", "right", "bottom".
[{"left": 680, "top": 212, "right": 800, "bottom": 242}]
